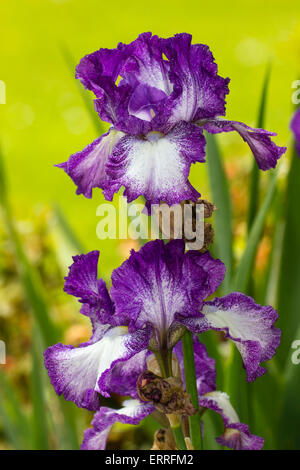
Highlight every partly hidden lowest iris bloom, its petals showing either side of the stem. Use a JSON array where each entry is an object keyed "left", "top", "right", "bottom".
[{"left": 81, "top": 337, "right": 264, "bottom": 450}]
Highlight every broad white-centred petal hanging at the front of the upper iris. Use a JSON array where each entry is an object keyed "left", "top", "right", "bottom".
[{"left": 104, "top": 122, "right": 205, "bottom": 205}]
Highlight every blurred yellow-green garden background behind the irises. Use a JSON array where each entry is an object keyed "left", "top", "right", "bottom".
[{"left": 0, "top": 0, "right": 300, "bottom": 449}]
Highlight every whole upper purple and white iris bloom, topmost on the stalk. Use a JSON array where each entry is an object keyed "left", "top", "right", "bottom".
[{"left": 58, "top": 33, "right": 286, "bottom": 207}]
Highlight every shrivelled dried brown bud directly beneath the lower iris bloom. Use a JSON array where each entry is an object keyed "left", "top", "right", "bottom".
[{"left": 137, "top": 370, "right": 196, "bottom": 415}]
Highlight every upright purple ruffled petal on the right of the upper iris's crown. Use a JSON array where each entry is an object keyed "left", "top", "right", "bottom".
[{"left": 161, "top": 33, "right": 229, "bottom": 124}]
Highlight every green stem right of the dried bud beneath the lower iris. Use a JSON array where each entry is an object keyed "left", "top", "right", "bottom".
[{"left": 182, "top": 331, "right": 202, "bottom": 450}]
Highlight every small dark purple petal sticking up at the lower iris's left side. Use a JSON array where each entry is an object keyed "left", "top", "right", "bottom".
[{"left": 64, "top": 251, "right": 114, "bottom": 332}]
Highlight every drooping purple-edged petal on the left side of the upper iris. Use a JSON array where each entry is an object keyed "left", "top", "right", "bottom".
[{"left": 56, "top": 130, "right": 124, "bottom": 198}]
